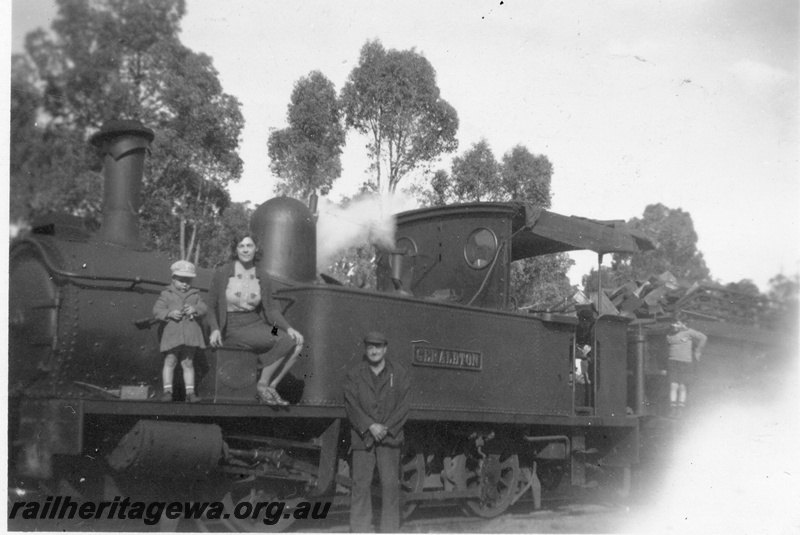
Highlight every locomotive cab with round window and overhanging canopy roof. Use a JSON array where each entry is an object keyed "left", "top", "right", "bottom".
[{"left": 377, "top": 202, "right": 653, "bottom": 310}]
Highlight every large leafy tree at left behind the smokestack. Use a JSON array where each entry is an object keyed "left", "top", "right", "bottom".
[{"left": 11, "top": 0, "right": 244, "bottom": 266}]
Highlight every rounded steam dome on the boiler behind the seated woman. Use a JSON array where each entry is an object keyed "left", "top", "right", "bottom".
[{"left": 250, "top": 197, "right": 317, "bottom": 282}]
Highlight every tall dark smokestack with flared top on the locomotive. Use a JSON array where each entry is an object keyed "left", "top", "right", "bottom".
[{"left": 89, "top": 119, "right": 155, "bottom": 249}]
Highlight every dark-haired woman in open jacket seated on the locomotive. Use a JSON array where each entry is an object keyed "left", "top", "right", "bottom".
[{"left": 207, "top": 234, "right": 303, "bottom": 405}]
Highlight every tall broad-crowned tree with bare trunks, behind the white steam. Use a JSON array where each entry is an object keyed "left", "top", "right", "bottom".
[{"left": 341, "top": 40, "right": 458, "bottom": 192}]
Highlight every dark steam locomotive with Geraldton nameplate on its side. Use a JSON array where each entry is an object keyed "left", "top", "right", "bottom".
[{"left": 9, "top": 121, "right": 653, "bottom": 530}]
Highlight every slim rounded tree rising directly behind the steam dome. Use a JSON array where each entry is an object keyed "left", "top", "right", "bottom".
[{"left": 267, "top": 71, "right": 345, "bottom": 199}]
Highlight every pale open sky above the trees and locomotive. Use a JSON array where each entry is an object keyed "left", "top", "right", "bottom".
[{"left": 10, "top": 0, "right": 800, "bottom": 290}]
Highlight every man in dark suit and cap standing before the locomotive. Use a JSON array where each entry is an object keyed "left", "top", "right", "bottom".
[{"left": 344, "top": 332, "right": 410, "bottom": 533}]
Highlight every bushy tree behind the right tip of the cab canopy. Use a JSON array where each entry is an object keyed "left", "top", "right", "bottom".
[{"left": 611, "top": 203, "right": 710, "bottom": 282}]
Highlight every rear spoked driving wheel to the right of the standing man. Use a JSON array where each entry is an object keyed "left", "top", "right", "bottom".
[{"left": 467, "top": 454, "right": 521, "bottom": 518}]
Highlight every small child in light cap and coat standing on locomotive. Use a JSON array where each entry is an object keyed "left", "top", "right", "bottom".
[{"left": 153, "top": 260, "right": 208, "bottom": 403}]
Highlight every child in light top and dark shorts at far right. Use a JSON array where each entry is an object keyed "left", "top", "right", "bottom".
[{"left": 667, "top": 315, "right": 708, "bottom": 418}]
